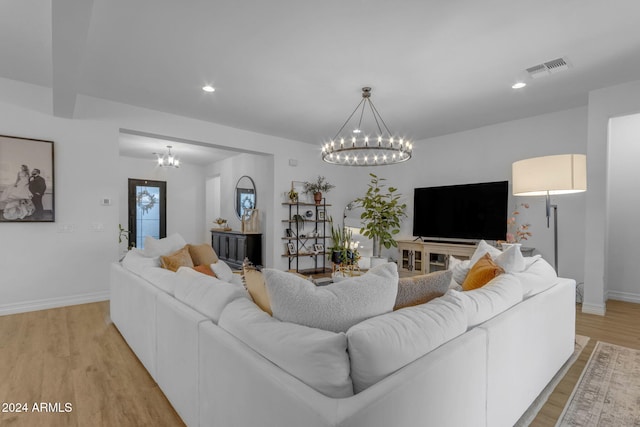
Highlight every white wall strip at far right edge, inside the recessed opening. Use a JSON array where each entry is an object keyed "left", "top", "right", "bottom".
[{"left": 606, "top": 114, "right": 640, "bottom": 303}]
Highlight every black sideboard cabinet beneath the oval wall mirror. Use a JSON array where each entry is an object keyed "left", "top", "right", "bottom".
[{"left": 211, "top": 230, "right": 262, "bottom": 269}]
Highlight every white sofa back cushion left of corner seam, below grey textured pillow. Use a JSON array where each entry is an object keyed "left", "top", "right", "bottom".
[{"left": 219, "top": 299, "right": 353, "bottom": 400}]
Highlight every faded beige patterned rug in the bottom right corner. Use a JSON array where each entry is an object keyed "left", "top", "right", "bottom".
[{"left": 556, "top": 341, "right": 640, "bottom": 427}]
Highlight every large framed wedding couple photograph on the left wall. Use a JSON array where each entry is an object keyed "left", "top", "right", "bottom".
[{"left": 0, "top": 135, "right": 55, "bottom": 223}]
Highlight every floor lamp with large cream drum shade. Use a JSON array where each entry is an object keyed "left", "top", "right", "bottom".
[{"left": 511, "top": 154, "right": 587, "bottom": 273}]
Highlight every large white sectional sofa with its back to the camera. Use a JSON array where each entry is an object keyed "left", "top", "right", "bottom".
[{"left": 111, "top": 239, "right": 575, "bottom": 427}]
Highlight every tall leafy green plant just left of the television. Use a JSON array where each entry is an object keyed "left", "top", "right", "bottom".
[{"left": 356, "top": 173, "right": 407, "bottom": 258}]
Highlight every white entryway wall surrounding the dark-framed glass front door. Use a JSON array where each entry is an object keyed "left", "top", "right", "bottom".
[{"left": 118, "top": 156, "right": 209, "bottom": 246}]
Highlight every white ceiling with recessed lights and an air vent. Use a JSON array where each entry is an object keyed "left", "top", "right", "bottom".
[{"left": 0, "top": 0, "right": 640, "bottom": 154}]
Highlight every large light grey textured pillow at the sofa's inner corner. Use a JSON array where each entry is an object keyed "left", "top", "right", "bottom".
[{"left": 263, "top": 263, "right": 398, "bottom": 332}]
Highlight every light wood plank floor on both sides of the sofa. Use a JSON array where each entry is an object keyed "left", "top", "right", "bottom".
[{"left": 0, "top": 301, "right": 640, "bottom": 427}]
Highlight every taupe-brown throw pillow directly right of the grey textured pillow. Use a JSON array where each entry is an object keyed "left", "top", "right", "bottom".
[{"left": 393, "top": 270, "right": 453, "bottom": 310}]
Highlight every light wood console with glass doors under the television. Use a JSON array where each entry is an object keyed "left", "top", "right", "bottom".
[{"left": 398, "top": 240, "right": 476, "bottom": 275}]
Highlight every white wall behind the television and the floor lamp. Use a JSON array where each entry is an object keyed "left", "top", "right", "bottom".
[{"left": 390, "top": 107, "right": 587, "bottom": 282}]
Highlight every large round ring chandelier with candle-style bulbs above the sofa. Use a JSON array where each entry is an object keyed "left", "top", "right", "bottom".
[{"left": 322, "top": 87, "right": 413, "bottom": 166}]
